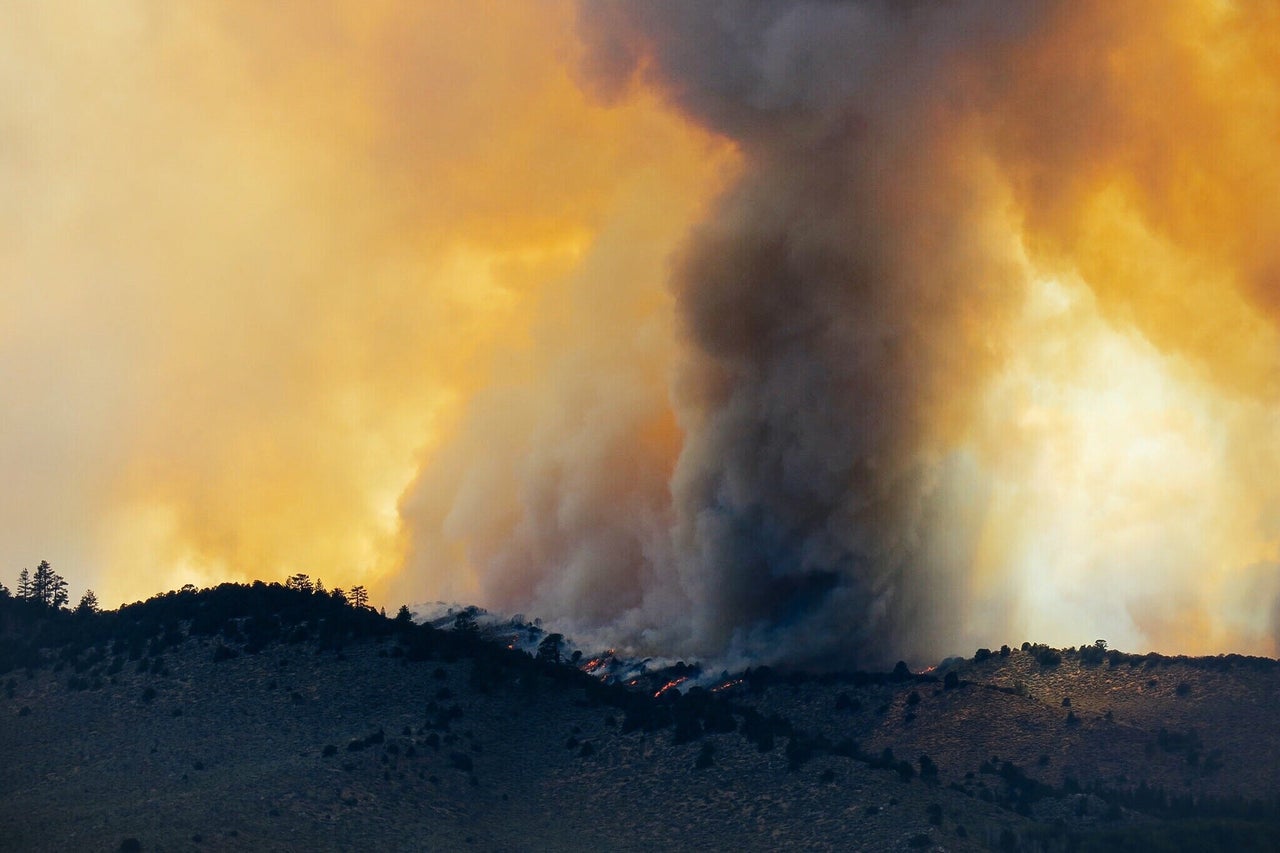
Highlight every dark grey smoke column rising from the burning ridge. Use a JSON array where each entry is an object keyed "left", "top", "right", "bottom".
[{"left": 580, "top": 1, "right": 1034, "bottom": 665}]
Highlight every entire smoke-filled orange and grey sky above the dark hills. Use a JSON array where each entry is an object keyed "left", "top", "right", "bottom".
[{"left": 0, "top": 0, "right": 1280, "bottom": 663}]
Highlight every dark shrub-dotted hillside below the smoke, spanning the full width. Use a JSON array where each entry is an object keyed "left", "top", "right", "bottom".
[{"left": 0, "top": 584, "right": 1280, "bottom": 850}]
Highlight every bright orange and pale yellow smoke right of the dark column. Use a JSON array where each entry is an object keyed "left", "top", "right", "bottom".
[{"left": 962, "top": 3, "right": 1280, "bottom": 654}]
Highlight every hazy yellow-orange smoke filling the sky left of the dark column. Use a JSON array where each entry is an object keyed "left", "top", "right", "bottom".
[{"left": 0, "top": 0, "right": 726, "bottom": 605}]
